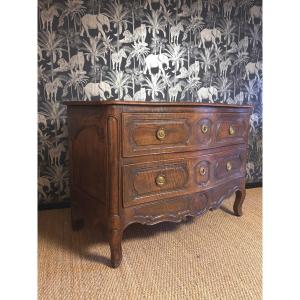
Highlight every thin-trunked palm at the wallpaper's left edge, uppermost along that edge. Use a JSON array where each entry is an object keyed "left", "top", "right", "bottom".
[{"left": 38, "top": 31, "right": 65, "bottom": 81}]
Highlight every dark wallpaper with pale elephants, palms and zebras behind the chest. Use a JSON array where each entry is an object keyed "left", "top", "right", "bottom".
[{"left": 38, "top": 0, "right": 262, "bottom": 204}]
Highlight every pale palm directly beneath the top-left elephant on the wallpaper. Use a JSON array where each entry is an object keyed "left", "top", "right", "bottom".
[{"left": 82, "top": 37, "right": 108, "bottom": 79}]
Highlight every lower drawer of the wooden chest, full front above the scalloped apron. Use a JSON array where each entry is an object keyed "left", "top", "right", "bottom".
[{"left": 122, "top": 148, "right": 246, "bottom": 207}]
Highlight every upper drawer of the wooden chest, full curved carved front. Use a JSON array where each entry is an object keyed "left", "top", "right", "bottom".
[{"left": 122, "top": 111, "right": 249, "bottom": 157}]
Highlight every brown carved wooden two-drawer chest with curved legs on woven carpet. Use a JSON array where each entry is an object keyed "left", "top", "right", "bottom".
[{"left": 65, "top": 101, "right": 252, "bottom": 267}]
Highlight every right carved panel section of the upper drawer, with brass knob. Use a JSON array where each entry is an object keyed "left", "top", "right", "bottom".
[{"left": 215, "top": 114, "right": 249, "bottom": 145}]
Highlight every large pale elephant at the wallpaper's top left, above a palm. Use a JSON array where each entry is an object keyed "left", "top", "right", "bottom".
[{"left": 80, "top": 14, "right": 110, "bottom": 38}]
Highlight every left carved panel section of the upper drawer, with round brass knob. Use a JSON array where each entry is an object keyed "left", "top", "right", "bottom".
[{"left": 123, "top": 113, "right": 192, "bottom": 156}]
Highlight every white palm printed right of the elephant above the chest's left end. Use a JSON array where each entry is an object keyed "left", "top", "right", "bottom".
[{"left": 107, "top": 70, "right": 130, "bottom": 99}]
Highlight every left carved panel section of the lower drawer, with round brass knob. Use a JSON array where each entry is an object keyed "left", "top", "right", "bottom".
[{"left": 123, "top": 161, "right": 189, "bottom": 206}]
